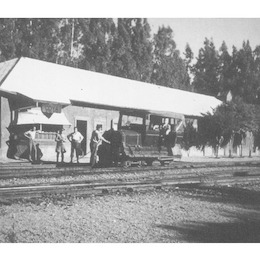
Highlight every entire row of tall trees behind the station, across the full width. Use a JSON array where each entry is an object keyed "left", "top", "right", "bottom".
[{"left": 0, "top": 18, "right": 260, "bottom": 104}]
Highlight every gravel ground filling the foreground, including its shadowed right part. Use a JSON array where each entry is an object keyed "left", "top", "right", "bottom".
[{"left": 0, "top": 183, "right": 260, "bottom": 243}]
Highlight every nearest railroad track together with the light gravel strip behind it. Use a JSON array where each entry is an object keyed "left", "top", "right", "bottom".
[{"left": 0, "top": 164, "right": 260, "bottom": 200}]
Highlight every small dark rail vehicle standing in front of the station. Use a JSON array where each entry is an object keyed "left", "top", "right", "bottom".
[{"left": 98, "top": 110, "right": 183, "bottom": 166}]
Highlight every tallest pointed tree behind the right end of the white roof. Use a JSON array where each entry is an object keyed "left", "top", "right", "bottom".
[{"left": 193, "top": 38, "right": 219, "bottom": 97}]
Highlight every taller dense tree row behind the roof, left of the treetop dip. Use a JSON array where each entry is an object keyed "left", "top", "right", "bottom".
[{"left": 0, "top": 18, "right": 190, "bottom": 90}]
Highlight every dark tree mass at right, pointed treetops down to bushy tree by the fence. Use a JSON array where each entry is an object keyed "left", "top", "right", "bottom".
[{"left": 184, "top": 38, "right": 260, "bottom": 155}]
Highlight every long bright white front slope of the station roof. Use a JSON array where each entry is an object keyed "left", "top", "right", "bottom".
[{"left": 1, "top": 58, "right": 221, "bottom": 116}]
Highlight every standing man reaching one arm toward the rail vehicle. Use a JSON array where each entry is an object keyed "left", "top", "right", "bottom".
[{"left": 90, "top": 125, "right": 110, "bottom": 167}]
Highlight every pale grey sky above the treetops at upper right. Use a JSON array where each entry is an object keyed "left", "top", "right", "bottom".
[{"left": 148, "top": 18, "right": 260, "bottom": 57}]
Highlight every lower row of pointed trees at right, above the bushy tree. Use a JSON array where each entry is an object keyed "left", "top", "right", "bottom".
[{"left": 185, "top": 38, "right": 260, "bottom": 104}]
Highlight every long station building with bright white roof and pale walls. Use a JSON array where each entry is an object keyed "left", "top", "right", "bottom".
[{"left": 0, "top": 57, "right": 221, "bottom": 161}]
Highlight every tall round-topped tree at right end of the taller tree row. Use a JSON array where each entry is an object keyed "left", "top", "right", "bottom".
[{"left": 151, "top": 26, "right": 189, "bottom": 90}]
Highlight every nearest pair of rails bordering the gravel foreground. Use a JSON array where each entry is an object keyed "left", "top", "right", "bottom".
[{"left": 0, "top": 168, "right": 260, "bottom": 199}]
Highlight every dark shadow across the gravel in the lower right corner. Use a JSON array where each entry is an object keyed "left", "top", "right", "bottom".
[{"left": 156, "top": 187, "right": 260, "bottom": 243}]
